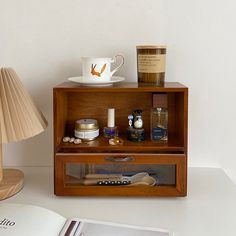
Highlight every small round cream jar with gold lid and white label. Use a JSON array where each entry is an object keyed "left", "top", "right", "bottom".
[{"left": 74, "top": 119, "right": 99, "bottom": 141}]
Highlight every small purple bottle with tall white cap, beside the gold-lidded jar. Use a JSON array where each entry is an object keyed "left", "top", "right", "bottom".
[{"left": 103, "top": 108, "right": 118, "bottom": 138}]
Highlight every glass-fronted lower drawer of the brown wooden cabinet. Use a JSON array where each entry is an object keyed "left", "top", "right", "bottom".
[{"left": 55, "top": 153, "right": 186, "bottom": 196}]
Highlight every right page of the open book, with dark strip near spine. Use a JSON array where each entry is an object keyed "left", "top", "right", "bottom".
[{"left": 59, "top": 219, "right": 170, "bottom": 236}]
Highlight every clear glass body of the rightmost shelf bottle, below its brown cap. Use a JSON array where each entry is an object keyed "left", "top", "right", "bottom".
[{"left": 150, "top": 107, "right": 168, "bottom": 142}]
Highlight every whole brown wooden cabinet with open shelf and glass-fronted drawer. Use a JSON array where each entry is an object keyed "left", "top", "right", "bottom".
[{"left": 53, "top": 82, "right": 188, "bottom": 196}]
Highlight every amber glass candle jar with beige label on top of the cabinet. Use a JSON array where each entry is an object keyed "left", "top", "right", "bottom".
[{"left": 136, "top": 45, "right": 166, "bottom": 86}]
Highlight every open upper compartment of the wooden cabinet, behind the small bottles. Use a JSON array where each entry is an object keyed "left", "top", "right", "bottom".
[{"left": 54, "top": 89, "right": 187, "bottom": 151}]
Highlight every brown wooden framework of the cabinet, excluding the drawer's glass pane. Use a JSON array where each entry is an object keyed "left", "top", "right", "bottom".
[{"left": 53, "top": 82, "right": 188, "bottom": 196}]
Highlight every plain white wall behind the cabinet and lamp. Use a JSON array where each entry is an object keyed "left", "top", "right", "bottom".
[{"left": 0, "top": 0, "right": 236, "bottom": 182}]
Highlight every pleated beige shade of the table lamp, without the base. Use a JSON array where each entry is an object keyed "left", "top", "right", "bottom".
[{"left": 0, "top": 68, "right": 47, "bottom": 143}]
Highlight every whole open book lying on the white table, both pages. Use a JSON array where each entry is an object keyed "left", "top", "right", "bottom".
[{"left": 0, "top": 204, "right": 172, "bottom": 236}]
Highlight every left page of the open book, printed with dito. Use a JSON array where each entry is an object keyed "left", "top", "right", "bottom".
[{"left": 0, "top": 204, "right": 66, "bottom": 236}]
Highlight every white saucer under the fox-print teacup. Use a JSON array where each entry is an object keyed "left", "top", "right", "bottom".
[{"left": 68, "top": 76, "right": 125, "bottom": 87}]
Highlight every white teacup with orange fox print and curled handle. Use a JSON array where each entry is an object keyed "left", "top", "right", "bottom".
[{"left": 82, "top": 54, "right": 124, "bottom": 82}]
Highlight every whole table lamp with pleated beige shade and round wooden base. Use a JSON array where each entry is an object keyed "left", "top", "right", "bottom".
[{"left": 0, "top": 68, "right": 47, "bottom": 200}]
